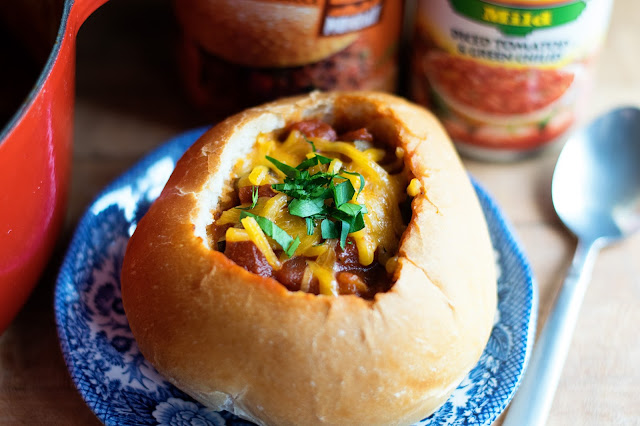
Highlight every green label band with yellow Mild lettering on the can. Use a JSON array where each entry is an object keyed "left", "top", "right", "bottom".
[{"left": 450, "top": 0, "right": 586, "bottom": 36}]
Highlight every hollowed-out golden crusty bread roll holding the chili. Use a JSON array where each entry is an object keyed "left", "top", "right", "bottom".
[{"left": 122, "top": 92, "right": 496, "bottom": 425}]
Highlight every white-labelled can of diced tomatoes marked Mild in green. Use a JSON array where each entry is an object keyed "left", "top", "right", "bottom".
[{"left": 410, "top": 0, "right": 613, "bottom": 160}]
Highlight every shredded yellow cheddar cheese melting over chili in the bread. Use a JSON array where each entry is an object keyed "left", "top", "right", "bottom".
[{"left": 215, "top": 125, "right": 412, "bottom": 295}]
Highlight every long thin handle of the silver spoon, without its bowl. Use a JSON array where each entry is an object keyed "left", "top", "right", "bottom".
[{"left": 503, "top": 240, "right": 599, "bottom": 426}]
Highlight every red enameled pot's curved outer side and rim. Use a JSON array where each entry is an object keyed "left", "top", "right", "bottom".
[{"left": 0, "top": 0, "right": 107, "bottom": 334}]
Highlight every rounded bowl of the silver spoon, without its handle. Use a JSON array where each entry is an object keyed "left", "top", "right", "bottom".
[{"left": 551, "top": 108, "right": 640, "bottom": 244}]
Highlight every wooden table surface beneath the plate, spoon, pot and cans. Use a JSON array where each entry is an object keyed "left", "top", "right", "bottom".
[{"left": 0, "top": 0, "right": 640, "bottom": 425}]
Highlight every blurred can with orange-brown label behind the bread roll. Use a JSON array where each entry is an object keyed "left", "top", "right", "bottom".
[{"left": 174, "top": 0, "right": 403, "bottom": 114}]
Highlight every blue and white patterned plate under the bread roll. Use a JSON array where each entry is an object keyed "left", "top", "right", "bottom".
[{"left": 55, "top": 129, "right": 537, "bottom": 426}]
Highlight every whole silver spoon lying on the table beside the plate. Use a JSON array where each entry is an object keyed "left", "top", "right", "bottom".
[{"left": 503, "top": 108, "right": 640, "bottom": 426}]
